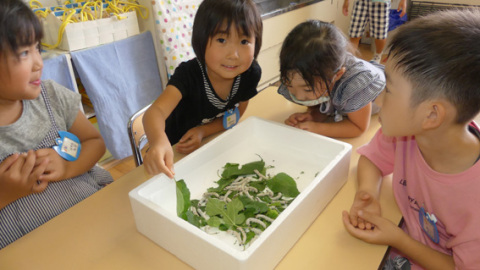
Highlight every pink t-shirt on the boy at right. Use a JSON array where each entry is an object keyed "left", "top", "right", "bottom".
[{"left": 358, "top": 128, "right": 480, "bottom": 269}]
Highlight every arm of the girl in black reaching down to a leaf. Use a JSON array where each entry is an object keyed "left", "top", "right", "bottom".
[{"left": 143, "top": 85, "right": 182, "bottom": 178}]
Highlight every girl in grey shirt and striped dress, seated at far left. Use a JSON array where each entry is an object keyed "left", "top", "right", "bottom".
[{"left": 0, "top": 0, "right": 112, "bottom": 248}]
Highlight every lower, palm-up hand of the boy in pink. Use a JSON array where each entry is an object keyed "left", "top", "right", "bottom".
[{"left": 342, "top": 210, "right": 404, "bottom": 246}]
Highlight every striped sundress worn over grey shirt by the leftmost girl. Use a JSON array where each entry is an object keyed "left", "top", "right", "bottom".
[{"left": 0, "top": 84, "right": 113, "bottom": 248}]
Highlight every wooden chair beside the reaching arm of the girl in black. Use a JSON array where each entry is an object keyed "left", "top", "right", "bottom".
[{"left": 127, "top": 104, "right": 151, "bottom": 167}]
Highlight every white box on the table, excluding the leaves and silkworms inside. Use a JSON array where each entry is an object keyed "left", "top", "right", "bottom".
[{"left": 129, "top": 117, "right": 352, "bottom": 270}]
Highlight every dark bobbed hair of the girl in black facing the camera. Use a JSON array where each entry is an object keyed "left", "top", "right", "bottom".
[{"left": 192, "top": 0, "right": 263, "bottom": 63}]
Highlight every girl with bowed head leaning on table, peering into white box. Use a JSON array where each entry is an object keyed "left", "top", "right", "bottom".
[{"left": 278, "top": 20, "right": 385, "bottom": 138}]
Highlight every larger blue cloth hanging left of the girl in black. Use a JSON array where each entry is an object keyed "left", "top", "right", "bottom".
[{"left": 71, "top": 32, "right": 163, "bottom": 159}]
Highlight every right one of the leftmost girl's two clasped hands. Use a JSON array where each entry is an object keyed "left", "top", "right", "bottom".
[{"left": 35, "top": 148, "right": 69, "bottom": 182}]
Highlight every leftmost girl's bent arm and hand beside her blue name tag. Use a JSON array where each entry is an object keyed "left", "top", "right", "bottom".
[{"left": 36, "top": 111, "right": 105, "bottom": 181}]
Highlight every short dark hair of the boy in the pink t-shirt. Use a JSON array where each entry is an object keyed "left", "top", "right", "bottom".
[{"left": 388, "top": 9, "right": 480, "bottom": 123}]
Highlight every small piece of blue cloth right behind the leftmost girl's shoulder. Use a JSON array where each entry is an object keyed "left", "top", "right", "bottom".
[{"left": 42, "top": 54, "right": 76, "bottom": 91}]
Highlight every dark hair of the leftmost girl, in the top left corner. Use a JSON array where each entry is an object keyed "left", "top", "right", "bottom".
[{"left": 0, "top": 0, "right": 43, "bottom": 53}]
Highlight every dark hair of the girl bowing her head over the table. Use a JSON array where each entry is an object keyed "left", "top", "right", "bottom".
[{"left": 280, "top": 20, "right": 351, "bottom": 93}]
